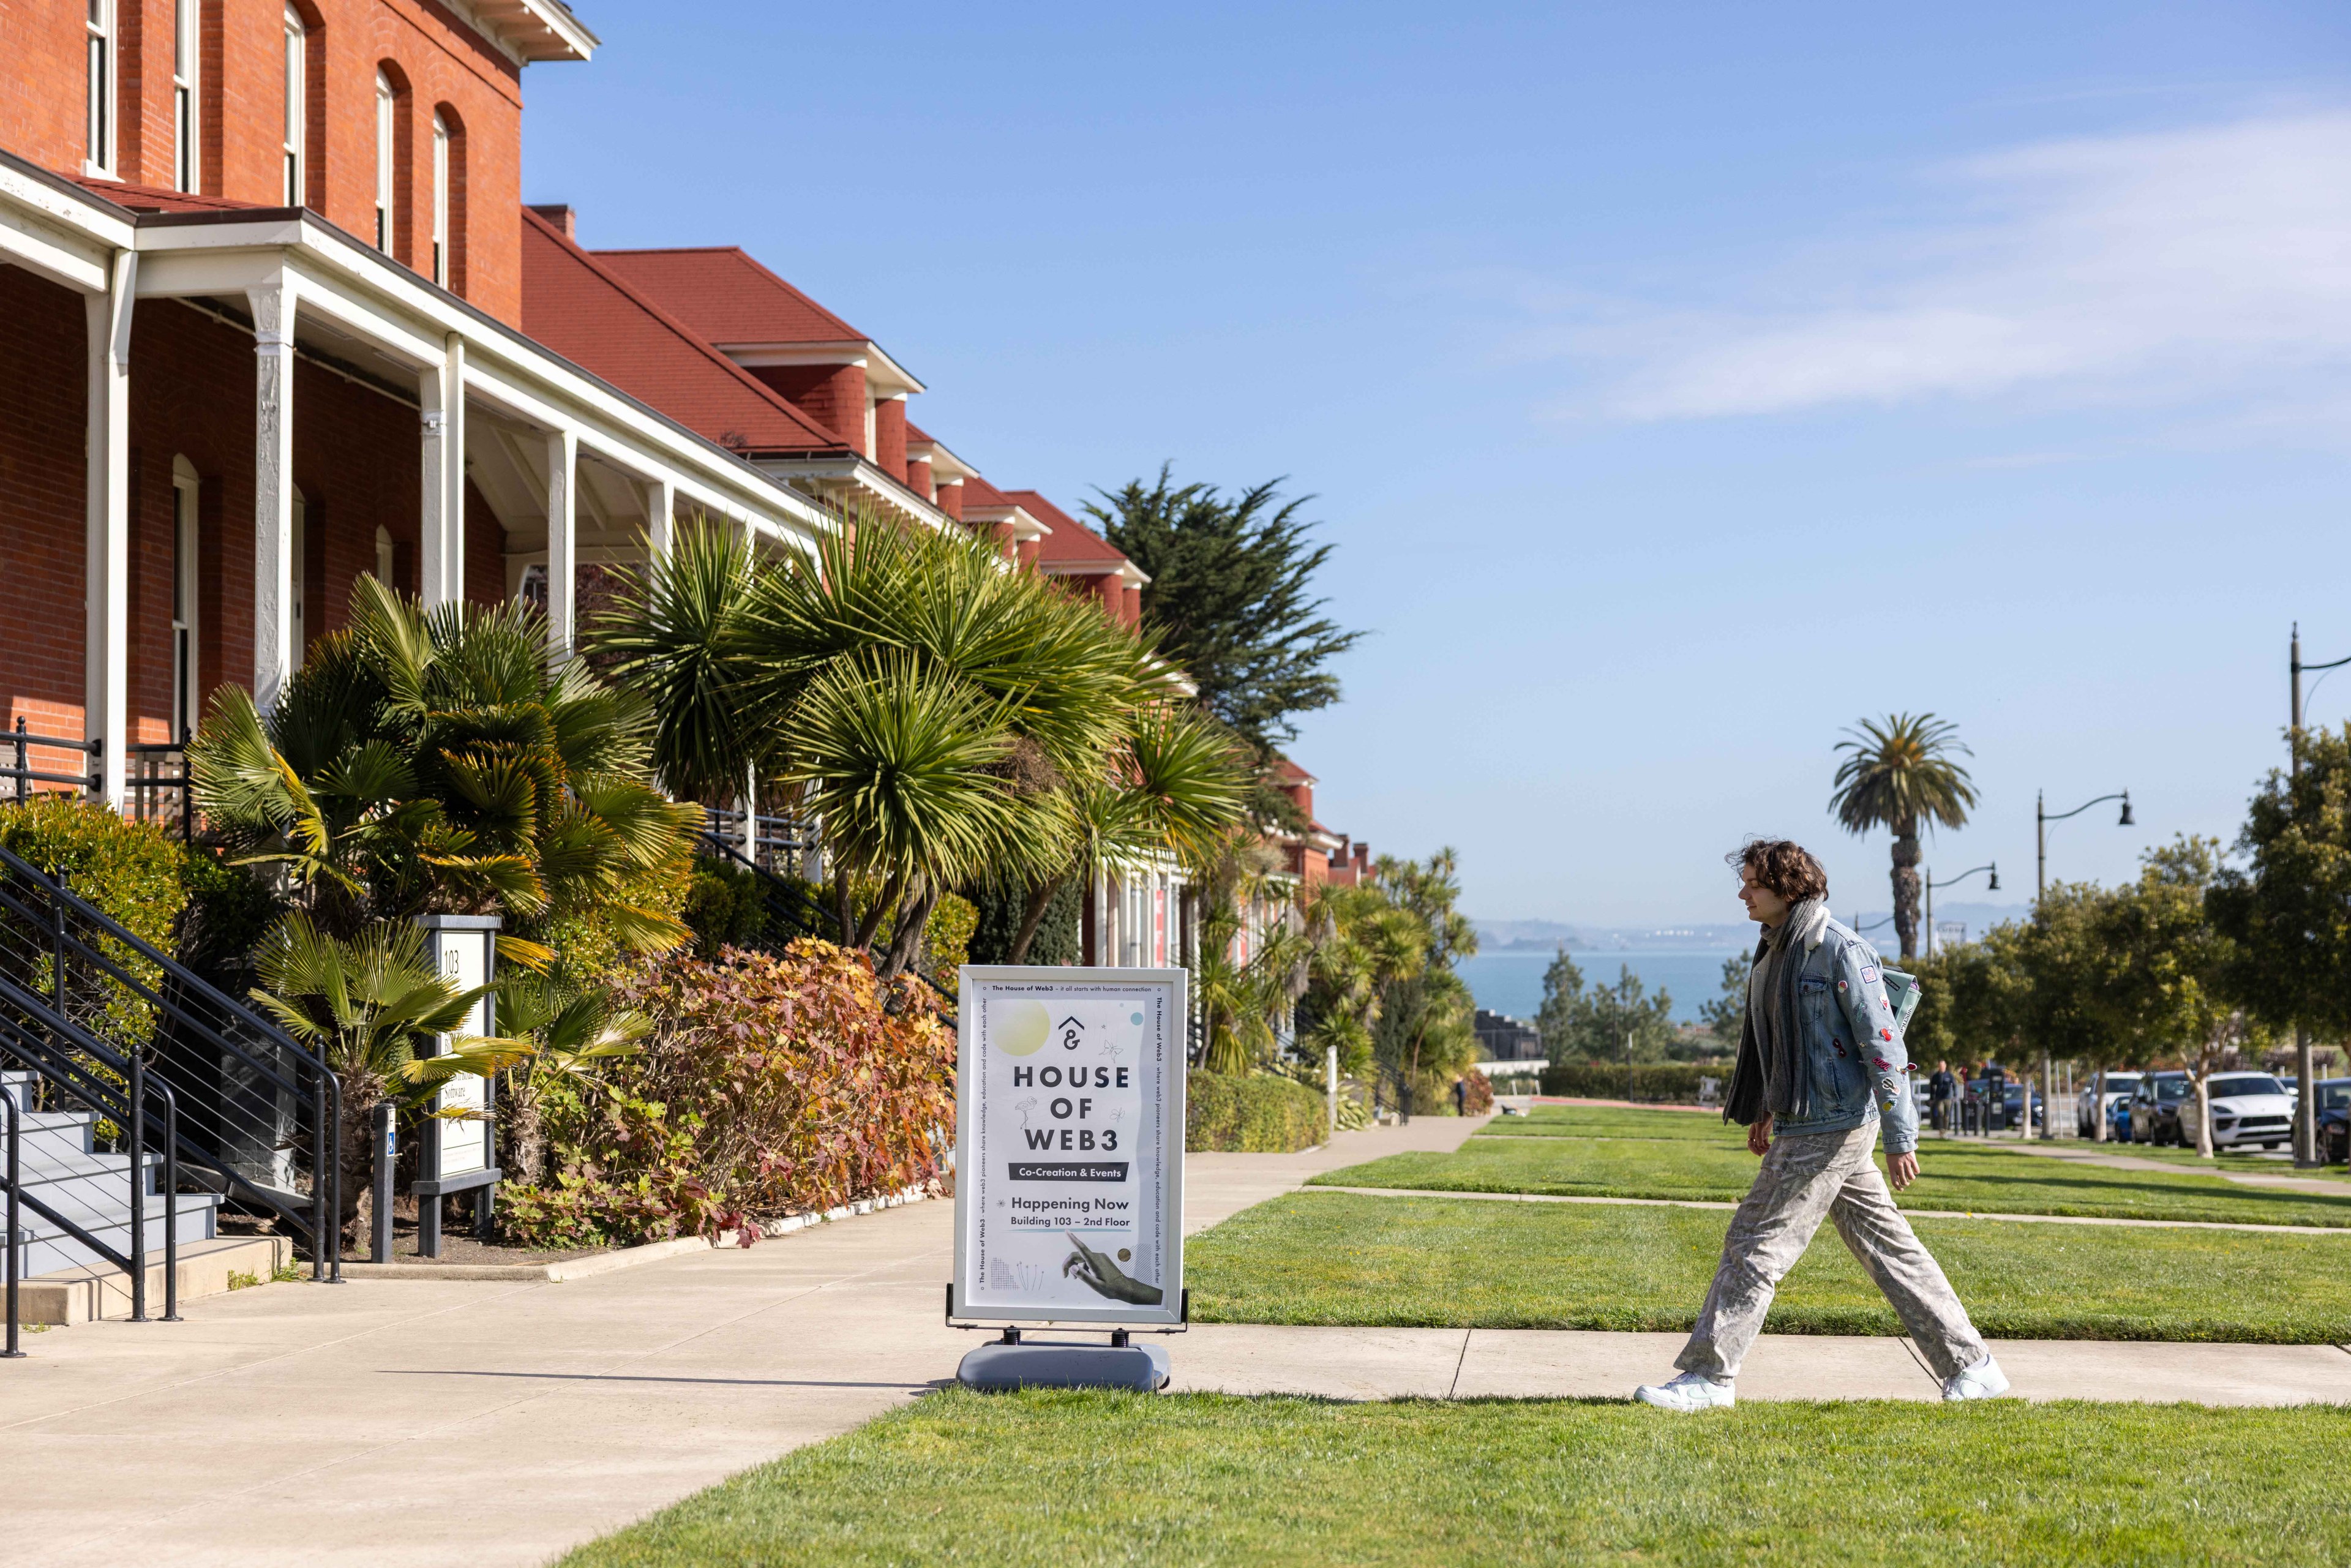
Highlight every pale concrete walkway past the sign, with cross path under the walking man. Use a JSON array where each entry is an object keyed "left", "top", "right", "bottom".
[{"left": 0, "top": 1119, "right": 2351, "bottom": 1568}]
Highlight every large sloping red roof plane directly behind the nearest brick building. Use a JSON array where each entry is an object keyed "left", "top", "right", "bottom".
[{"left": 522, "top": 207, "right": 849, "bottom": 456}]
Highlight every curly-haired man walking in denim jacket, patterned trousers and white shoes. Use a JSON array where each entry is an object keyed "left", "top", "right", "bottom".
[{"left": 1634, "top": 839, "right": 2008, "bottom": 1411}]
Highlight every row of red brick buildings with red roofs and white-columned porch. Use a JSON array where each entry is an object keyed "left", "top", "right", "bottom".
[{"left": 0, "top": 0, "right": 1329, "bottom": 982}]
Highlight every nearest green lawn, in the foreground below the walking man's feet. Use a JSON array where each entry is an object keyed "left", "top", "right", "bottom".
[{"left": 562, "top": 1392, "right": 2351, "bottom": 1568}]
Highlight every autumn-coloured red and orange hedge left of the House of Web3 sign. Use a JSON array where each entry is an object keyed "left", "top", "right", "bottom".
[{"left": 498, "top": 940, "right": 954, "bottom": 1246}]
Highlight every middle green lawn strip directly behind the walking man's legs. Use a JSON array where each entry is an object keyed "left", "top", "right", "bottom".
[{"left": 1185, "top": 1192, "right": 2351, "bottom": 1345}]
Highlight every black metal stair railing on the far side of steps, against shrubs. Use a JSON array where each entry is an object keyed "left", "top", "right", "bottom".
[{"left": 0, "top": 849, "right": 343, "bottom": 1279}]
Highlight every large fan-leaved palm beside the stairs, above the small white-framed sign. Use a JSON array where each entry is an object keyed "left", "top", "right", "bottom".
[{"left": 188, "top": 576, "right": 700, "bottom": 964}]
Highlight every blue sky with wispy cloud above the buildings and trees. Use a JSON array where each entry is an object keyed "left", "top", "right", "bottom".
[{"left": 524, "top": 0, "right": 2351, "bottom": 924}]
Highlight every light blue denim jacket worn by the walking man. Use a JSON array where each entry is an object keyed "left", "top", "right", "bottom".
[{"left": 1772, "top": 919, "right": 1918, "bottom": 1154}]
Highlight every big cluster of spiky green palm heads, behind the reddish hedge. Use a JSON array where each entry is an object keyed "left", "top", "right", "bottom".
[{"left": 588, "top": 517, "right": 1243, "bottom": 980}]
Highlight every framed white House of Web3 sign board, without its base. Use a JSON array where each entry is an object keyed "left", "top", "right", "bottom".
[{"left": 954, "top": 964, "right": 1187, "bottom": 1324}]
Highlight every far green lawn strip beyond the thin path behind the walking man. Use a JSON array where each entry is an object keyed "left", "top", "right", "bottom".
[{"left": 1314, "top": 1107, "right": 2351, "bottom": 1227}]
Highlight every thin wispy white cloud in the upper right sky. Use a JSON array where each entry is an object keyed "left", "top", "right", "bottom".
[{"left": 1573, "top": 113, "right": 2351, "bottom": 418}]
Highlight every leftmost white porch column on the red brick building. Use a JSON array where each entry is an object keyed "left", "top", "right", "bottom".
[{"left": 82, "top": 252, "right": 139, "bottom": 809}]
